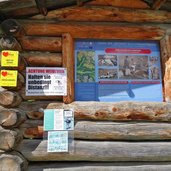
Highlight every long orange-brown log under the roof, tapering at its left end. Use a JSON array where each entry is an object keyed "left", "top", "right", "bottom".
[{"left": 32, "top": 7, "right": 171, "bottom": 23}]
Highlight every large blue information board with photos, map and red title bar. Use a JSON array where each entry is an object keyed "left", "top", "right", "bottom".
[{"left": 75, "top": 39, "right": 163, "bottom": 102}]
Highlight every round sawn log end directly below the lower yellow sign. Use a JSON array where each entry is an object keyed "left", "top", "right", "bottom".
[{"left": 0, "top": 91, "right": 22, "bottom": 107}]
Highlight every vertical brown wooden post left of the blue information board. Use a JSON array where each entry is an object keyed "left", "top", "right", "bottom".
[{"left": 62, "top": 33, "right": 74, "bottom": 103}]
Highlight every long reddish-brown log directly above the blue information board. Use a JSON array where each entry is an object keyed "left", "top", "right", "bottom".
[{"left": 20, "top": 21, "right": 165, "bottom": 40}]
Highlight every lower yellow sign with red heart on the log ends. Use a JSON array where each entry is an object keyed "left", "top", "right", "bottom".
[{"left": 0, "top": 70, "right": 18, "bottom": 87}]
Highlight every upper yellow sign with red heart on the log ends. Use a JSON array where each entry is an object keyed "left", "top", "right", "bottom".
[{"left": 1, "top": 50, "right": 19, "bottom": 67}]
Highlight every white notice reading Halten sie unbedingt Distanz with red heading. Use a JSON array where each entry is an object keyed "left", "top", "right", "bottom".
[{"left": 26, "top": 67, "right": 67, "bottom": 96}]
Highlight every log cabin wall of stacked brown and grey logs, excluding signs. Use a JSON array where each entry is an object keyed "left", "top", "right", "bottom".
[{"left": 0, "top": 0, "right": 171, "bottom": 171}]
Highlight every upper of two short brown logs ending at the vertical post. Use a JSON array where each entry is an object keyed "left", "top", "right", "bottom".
[{"left": 17, "top": 36, "right": 62, "bottom": 52}]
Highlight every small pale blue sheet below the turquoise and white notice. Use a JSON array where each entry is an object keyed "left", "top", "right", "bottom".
[{"left": 47, "top": 131, "right": 68, "bottom": 152}]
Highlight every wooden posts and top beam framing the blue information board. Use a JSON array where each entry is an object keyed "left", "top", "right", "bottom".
[{"left": 62, "top": 24, "right": 171, "bottom": 104}]
